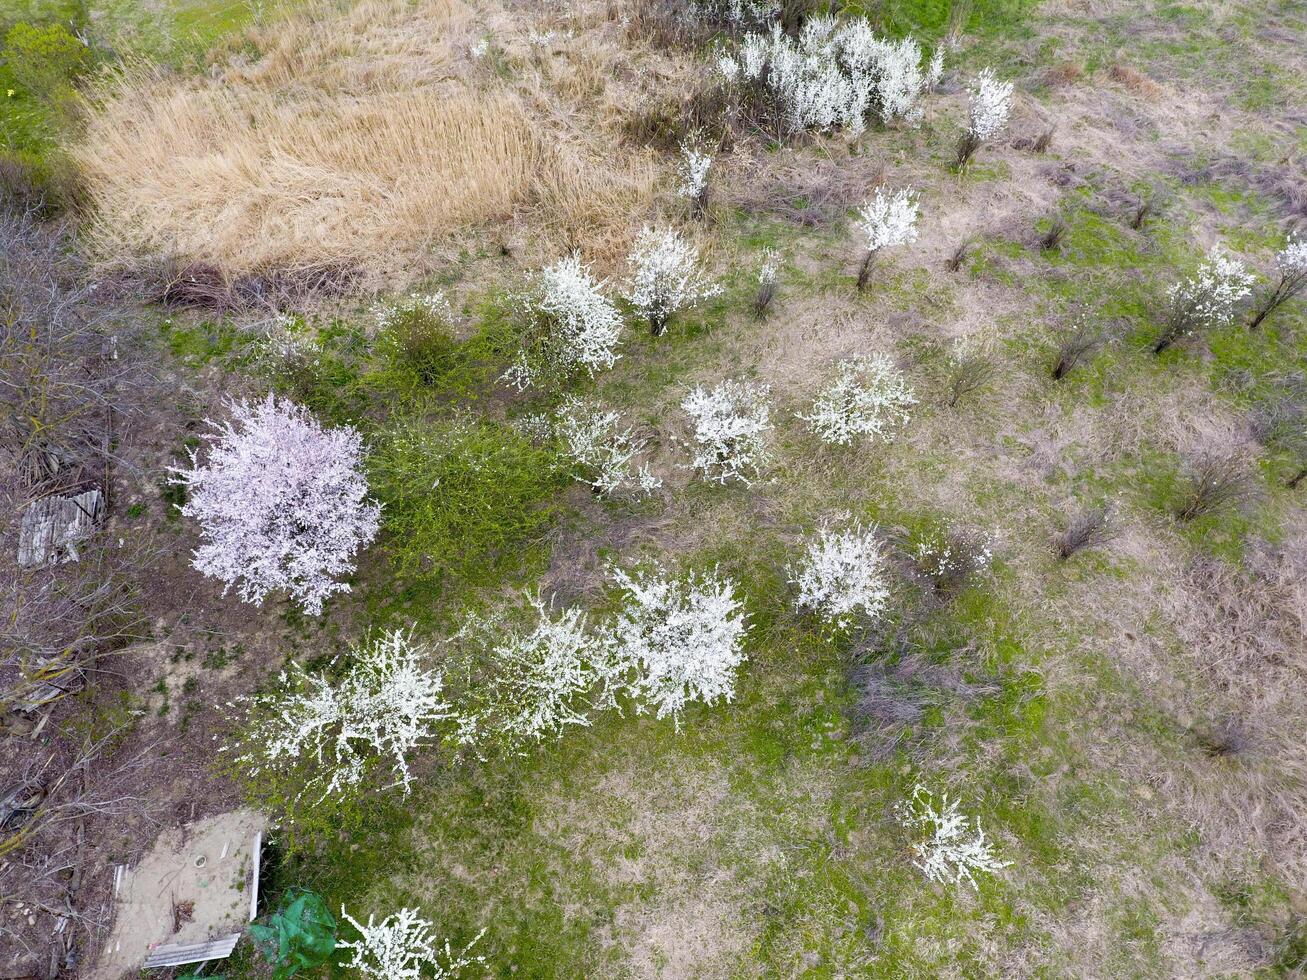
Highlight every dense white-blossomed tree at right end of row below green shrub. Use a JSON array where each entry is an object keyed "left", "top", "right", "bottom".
[{"left": 609, "top": 566, "right": 748, "bottom": 725}]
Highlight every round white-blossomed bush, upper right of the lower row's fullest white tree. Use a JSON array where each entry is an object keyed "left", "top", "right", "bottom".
[{"left": 789, "top": 521, "right": 890, "bottom": 629}]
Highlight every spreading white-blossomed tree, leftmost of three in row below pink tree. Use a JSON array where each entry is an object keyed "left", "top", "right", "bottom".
[{"left": 228, "top": 630, "right": 459, "bottom": 797}]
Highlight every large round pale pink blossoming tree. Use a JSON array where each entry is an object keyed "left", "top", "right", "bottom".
[{"left": 170, "top": 395, "right": 380, "bottom": 615}]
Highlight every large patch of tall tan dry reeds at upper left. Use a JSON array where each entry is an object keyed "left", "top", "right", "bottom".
[{"left": 76, "top": 0, "right": 655, "bottom": 285}]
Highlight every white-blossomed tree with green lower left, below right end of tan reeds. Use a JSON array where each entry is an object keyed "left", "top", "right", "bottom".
[{"left": 505, "top": 253, "right": 622, "bottom": 391}]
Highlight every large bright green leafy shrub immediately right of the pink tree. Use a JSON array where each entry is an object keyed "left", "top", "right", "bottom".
[{"left": 370, "top": 419, "right": 567, "bottom": 583}]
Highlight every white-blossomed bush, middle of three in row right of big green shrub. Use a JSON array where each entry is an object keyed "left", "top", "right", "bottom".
[{"left": 681, "top": 380, "right": 772, "bottom": 485}]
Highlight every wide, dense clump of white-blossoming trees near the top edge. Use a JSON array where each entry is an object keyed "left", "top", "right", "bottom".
[{"left": 718, "top": 17, "right": 929, "bottom": 136}]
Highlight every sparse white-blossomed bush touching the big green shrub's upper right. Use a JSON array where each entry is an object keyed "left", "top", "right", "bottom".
[{"left": 553, "top": 397, "right": 663, "bottom": 497}]
